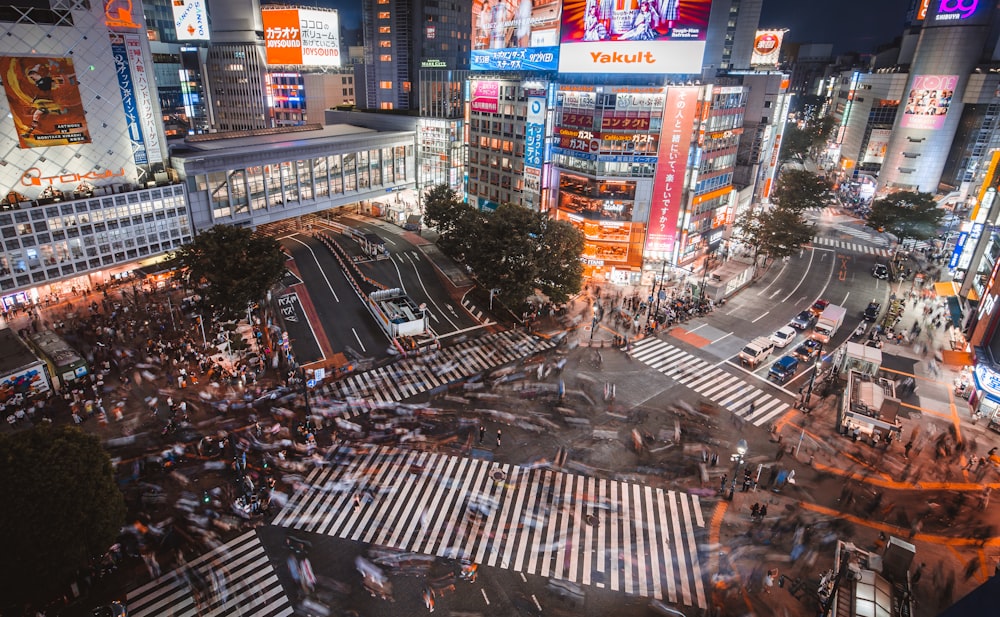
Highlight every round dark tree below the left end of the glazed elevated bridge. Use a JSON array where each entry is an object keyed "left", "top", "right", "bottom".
[{"left": 177, "top": 225, "right": 288, "bottom": 321}]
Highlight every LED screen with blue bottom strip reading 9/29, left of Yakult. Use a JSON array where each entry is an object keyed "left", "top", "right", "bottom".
[{"left": 470, "top": 0, "right": 562, "bottom": 71}]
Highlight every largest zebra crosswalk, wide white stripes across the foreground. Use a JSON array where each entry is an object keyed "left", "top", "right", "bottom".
[{"left": 273, "top": 446, "right": 706, "bottom": 607}]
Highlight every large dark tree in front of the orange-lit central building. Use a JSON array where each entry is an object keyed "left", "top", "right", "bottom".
[{"left": 457, "top": 204, "right": 583, "bottom": 307}]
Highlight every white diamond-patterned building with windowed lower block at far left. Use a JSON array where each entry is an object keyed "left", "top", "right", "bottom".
[{"left": 0, "top": 1, "right": 192, "bottom": 308}]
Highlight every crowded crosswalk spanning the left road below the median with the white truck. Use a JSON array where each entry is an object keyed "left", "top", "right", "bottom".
[{"left": 322, "top": 330, "right": 555, "bottom": 403}]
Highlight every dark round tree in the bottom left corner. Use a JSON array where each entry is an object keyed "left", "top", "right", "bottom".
[{"left": 0, "top": 426, "right": 125, "bottom": 603}]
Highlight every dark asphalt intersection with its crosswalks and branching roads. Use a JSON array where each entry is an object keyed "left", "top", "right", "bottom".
[{"left": 29, "top": 208, "right": 1000, "bottom": 617}]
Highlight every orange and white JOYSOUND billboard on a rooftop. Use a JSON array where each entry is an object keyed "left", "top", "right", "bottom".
[{"left": 261, "top": 8, "right": 340, "bottom": 67}]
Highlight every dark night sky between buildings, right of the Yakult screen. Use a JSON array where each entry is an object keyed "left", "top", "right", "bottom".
[{"left": 760, "top": 0, "right": 910, "bottom": 53}]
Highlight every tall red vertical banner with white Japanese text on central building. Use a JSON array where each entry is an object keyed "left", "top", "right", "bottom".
[{"left": 643, "top": 87, "right": 698, "bottom": 259}]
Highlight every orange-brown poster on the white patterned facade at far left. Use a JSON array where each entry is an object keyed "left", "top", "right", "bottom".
[{"left": 0, "top": 56, "right": 90, "bottom": 148}]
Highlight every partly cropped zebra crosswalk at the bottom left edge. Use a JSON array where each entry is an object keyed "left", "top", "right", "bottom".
[{"left": 126, "top": 531, "right": 295, "bottom": 617}]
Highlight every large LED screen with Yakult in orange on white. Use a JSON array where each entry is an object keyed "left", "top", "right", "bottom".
[{"left": 559, "top": 0, "right": 712, "bottom": 74}]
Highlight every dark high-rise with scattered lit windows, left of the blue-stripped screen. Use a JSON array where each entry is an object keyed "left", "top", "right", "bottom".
[{"left": 355, "top": 0, "right": 472, "bottom": 109}]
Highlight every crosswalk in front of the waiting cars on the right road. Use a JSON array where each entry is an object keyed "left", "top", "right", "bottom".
[{"left": 629, "top": 337, "right": 789, "bottom": 426}]
